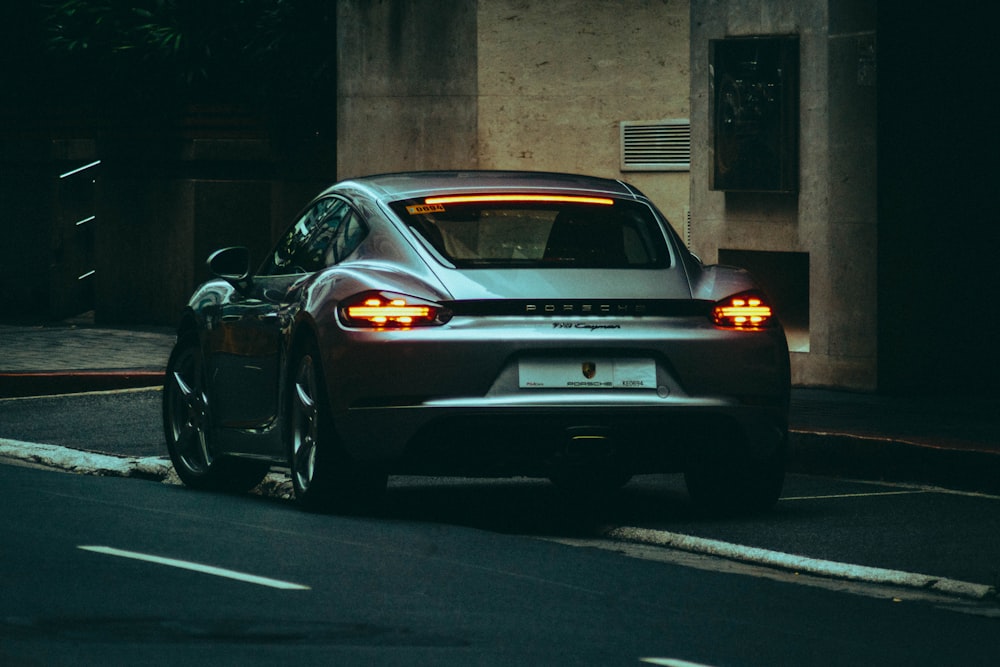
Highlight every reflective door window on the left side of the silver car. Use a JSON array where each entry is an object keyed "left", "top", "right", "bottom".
[{"left": 259, "top": 197, "right": 350, "bottom": 276}]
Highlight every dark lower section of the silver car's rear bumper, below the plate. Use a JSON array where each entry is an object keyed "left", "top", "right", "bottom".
[{"left": 340, "top": 397, "right": 787, "bottom": 476}]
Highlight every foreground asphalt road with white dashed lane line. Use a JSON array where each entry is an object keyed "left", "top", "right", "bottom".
[{"left": 0, "top": 465, "right": 1000, "bottom": 665}]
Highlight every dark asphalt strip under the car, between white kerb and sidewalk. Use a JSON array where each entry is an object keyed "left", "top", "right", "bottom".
[{"left": 0, "top": 390, "right": 1000, "bottom": 588}]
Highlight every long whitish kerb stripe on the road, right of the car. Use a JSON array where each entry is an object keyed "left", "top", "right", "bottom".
[{"left": 604, "top": 526, "right": 996, "bottom": 600}]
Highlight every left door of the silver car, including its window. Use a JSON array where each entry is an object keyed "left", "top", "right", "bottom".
[{"left": 209, "top": 197, "right": 350, "bottom": 438}]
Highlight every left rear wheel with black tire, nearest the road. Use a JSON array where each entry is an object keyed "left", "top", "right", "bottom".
[{"left": 286, "top": 341, "right": 388, "bottom": 514}]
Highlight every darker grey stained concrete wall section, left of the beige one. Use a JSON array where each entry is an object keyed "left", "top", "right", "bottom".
[{"left": 337, "top": 0, "right": 477, "bottom": 179}]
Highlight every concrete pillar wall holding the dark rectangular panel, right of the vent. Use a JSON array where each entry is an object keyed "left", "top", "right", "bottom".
[{"left": 691, "top": 0, "right": 878, "bottom": 390}]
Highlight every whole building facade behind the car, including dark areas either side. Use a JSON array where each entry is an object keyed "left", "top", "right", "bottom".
[{"left": 0, "top": 0, "right": 1000, "bottom": 395}]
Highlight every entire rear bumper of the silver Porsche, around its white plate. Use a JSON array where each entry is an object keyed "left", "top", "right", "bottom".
[{"left": 326, "top": 318, "right": 789, "bottom": 475}]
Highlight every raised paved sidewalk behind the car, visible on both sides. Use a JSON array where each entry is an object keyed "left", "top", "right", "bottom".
[{"left": 0, "top": 322, "right": 1000, "bottom": 493}]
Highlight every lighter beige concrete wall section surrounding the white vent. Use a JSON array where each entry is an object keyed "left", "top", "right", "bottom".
[{"left": 478, "top": 0, "right": 689, "bottom": 227}]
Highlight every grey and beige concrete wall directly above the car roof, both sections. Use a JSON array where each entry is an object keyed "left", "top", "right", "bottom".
[{"left": 337, "top": 0, "right": 689, "bottom": 233}]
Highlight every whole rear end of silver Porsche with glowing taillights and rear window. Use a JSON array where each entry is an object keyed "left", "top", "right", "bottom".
[{"left": 320, "top": 175, "right": 788, "bottom": 482}]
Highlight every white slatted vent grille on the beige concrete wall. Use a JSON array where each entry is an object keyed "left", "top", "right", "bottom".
[{"left": 621, "top": 118, "right": 691, "bottom": 171}]
